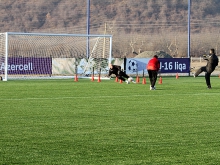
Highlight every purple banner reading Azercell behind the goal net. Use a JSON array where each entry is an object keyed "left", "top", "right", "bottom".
[{"left": 0, "top": 57, "right": 52, "bottom": 75}]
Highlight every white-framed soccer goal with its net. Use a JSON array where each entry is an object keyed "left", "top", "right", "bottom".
[{"left": 0, "top": 32, "right": 112, "bottom": 81}]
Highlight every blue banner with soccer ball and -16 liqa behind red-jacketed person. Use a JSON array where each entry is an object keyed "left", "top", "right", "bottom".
[{"left": 126, "top": 58, "right": 190, "bottom": 74}]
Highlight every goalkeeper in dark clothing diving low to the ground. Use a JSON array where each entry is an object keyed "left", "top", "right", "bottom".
[{"left": 108, "top": 64, "right": 135, "bottom": 84}]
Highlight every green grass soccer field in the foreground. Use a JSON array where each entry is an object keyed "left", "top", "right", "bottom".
[{"left": 0, "top": 77, "right": 220, "bottom": 165}]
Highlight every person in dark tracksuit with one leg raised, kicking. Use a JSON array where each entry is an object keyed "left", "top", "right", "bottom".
[{"left": 194, "top": 49, "right": 218, "bottom": 89}]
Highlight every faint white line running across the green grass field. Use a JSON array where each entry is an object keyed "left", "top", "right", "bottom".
[{"left": 0, "top": 93, "right": 220, "bottom": 101}]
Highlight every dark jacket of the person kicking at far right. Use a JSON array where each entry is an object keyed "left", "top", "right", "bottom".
[{"left": 203, "top": 53, "right": 218, "bottom": 73}]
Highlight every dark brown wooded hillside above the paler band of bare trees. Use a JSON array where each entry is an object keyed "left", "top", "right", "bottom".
[{"left": 0, "top": 0, "right": 220, "bottom": 32}]
